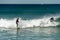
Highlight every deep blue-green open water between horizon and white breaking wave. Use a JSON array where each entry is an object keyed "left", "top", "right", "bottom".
[{"left": 0, "top": 4, "right": 60, "bottom": 19}]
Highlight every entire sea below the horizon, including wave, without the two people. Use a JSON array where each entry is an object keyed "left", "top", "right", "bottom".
[{"left": 0, "top": 4, "right": 60, "bottom": 40}]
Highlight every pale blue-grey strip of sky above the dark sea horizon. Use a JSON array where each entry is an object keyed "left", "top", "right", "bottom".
[{"left": 0, "top": 0, "right": 60, "bottom": 4}]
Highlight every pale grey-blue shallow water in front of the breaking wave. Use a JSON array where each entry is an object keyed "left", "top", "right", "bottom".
[{"left": 0, "top": 27, "right": 60, "bottom": 40}]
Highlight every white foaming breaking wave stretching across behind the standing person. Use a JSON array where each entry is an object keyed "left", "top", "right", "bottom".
[{"left": 0, "top": 17, "right": 60, "bottom": 28}]
